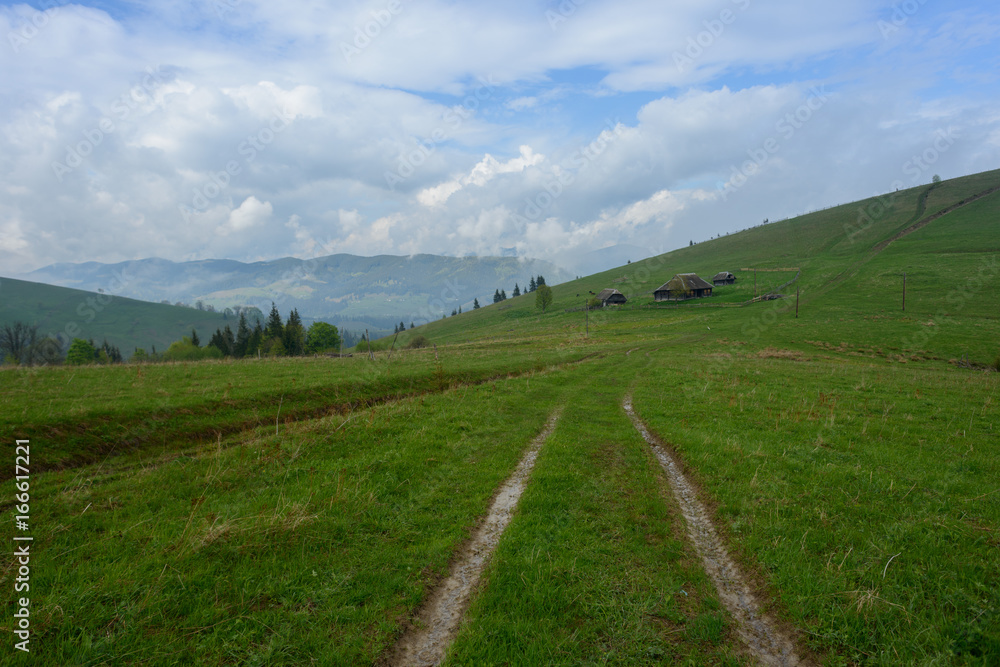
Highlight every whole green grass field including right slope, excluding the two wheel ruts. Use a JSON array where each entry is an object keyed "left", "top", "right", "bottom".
[{"left": 0, "top": 172, "right": 1000, "bottom": 665}]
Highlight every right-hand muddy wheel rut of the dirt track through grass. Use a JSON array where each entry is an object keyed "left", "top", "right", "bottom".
[{"left": 622, "top": 396, "right": 809, "bottom": 667}]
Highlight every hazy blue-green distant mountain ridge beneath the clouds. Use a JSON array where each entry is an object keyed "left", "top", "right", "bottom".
[{"left": 20, "top": 254, "right": 573, "bottom": 328}]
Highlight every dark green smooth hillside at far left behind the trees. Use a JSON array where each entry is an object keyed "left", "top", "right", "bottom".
[{"left": 0, "top": 278, "right": 229, "bottom": 358}]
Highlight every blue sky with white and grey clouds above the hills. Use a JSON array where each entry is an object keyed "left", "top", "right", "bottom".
[{"left": 0, "top": 0, "right": 1000, "bottom": 275}]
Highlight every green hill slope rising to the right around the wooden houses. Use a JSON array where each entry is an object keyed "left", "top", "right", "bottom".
[{"left": 388, "top": 171, "right": 1000, "bottom": 361}]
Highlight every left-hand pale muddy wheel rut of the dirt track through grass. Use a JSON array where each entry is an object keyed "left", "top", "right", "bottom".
[{"left": 388, "top": 408, "right": 562, "bottom": 667}]
